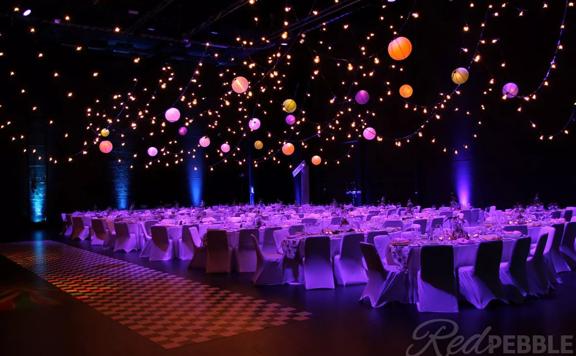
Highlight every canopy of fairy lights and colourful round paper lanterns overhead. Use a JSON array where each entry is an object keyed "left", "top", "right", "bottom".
[{"left": 0, "top": 0, "right": 576, "bottom": 171}]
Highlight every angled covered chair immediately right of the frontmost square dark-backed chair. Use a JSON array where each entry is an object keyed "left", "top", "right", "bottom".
[{"left": 458, "top": 241, "right": 507, "bottom": 309}]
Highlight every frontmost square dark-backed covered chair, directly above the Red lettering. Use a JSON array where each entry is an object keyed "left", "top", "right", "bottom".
[{"left": 416, "top": 246, "right": 458, "bottom": 313}]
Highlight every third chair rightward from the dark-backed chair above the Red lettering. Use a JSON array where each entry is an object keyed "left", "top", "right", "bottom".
[{"left": 526, "top": 232, "right": 556, "bottom": 297}]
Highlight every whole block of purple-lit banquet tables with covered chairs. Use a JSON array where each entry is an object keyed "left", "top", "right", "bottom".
[{"left": 62, "top": 204, "right": 576, "bottom": 312}]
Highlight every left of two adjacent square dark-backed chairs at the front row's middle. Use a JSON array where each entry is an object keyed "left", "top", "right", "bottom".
[{"left": 303, "top": 236, "right": 334, "bottom": 289}]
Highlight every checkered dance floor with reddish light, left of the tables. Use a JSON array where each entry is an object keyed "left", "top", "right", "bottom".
[{"left": 0, "top": 241, "right": 310, "bottom": 349}]
